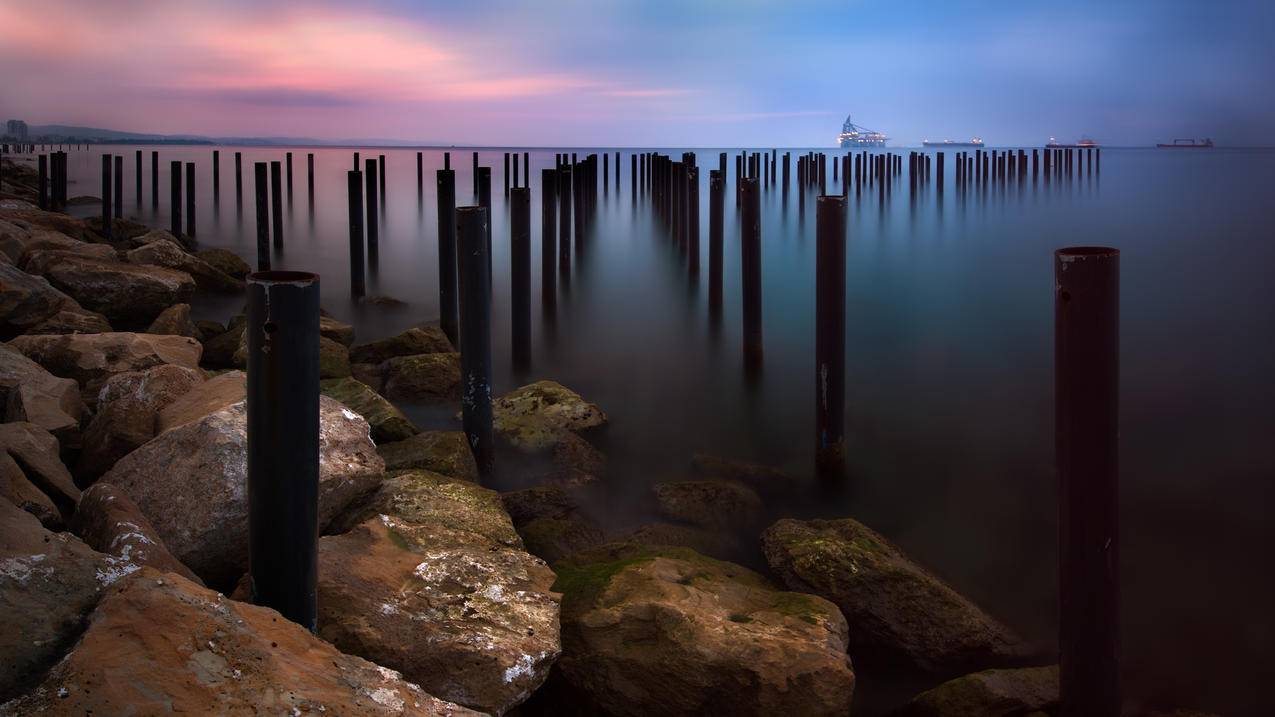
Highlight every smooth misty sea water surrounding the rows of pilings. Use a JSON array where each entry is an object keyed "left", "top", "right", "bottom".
[{"left": 52, "top": 145, "right": 1275, "bottom": 713}]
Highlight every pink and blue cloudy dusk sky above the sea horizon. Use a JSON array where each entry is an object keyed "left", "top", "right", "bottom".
[{"left": 0, "top": 0, "right": 1275, "bottom": 147}]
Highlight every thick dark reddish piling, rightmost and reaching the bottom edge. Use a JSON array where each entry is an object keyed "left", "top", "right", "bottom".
[{"left": 1054, "top": 246, "right": 1121, "bottom": 717}]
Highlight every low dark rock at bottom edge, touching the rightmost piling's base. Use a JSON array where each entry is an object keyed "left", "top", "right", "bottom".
[{"left": 895, "top": 665, "right": 1058, "bottom": 717}]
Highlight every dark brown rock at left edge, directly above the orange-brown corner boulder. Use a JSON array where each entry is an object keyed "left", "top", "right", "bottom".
[{"left": 0, "top": 500, "right": 136, "bottom": 699}]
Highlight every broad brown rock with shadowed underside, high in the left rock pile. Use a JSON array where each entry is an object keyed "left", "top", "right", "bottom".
[{"left": 26, "top": 251, "right": 195, "bottom": 328}]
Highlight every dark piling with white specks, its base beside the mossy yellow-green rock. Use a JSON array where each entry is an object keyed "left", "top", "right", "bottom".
[{"left": 456, "top": 207, "right": 493, "bottom": 478}]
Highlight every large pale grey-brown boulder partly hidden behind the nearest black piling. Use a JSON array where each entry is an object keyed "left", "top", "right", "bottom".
[{"left": 102, "top": 397, "right": 384, "bottom": 586}]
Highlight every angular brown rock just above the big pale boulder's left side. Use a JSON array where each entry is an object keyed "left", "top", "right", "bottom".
[{"left": 75, "top": 364, "right": 204, "bottom": 485}]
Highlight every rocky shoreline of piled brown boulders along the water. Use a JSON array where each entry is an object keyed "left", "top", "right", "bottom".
[{"left": 0, "top": 153, "right": 1213, "bottom": 717}]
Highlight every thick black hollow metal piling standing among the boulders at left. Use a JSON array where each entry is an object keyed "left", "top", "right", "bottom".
[{"left": 246, "top": 272, "right": 319, "bottom": 633}]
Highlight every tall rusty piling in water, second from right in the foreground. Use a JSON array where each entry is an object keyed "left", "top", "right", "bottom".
[{"left": 815, "top": 195, "right": 845, "bottom": 475}]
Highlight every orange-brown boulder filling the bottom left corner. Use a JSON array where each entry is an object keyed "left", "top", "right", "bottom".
[{"left": 0, "top": 568, "right": 477, "bottom": 717}]
